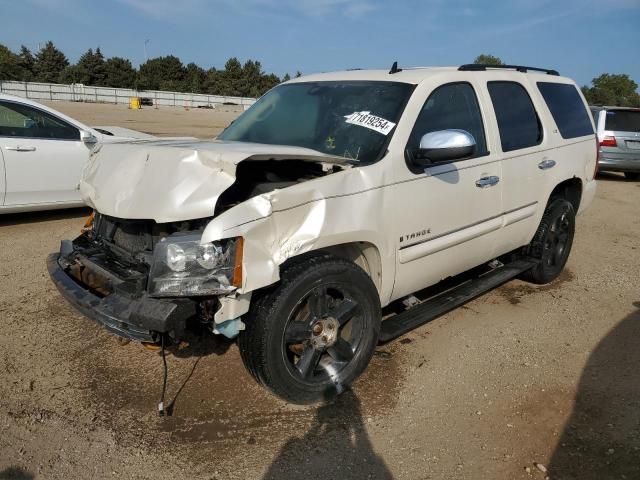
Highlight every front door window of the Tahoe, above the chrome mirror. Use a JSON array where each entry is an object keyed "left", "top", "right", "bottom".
[{"left": 408, "top": 83, "right": 487, "bottom": 157}]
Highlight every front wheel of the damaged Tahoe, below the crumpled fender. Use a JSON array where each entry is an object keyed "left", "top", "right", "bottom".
[{"left": 238, "top": 254, "right": 381, "bottom": 404}]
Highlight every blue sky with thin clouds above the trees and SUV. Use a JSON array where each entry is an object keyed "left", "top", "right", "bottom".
[{"left": 0, "top": 0, "right": 640, "bottom": 85}]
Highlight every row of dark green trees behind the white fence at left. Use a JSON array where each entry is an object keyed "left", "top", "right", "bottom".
[{"left": 0, "top": 41, "right": 301, "bottom": 98}]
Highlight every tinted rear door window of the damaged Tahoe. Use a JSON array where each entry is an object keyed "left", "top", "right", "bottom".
[{"left": 487, "top": 82, "right": 542, "bottom": 152}]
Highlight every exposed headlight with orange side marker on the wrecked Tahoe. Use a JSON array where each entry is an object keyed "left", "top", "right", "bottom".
[{"left": 149, "top": 235, "right": 242, "bottom": 297}]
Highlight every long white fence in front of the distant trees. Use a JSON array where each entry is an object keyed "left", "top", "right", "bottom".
[{"left": 0, "top": 81, "right": 256, "bottom": 108}]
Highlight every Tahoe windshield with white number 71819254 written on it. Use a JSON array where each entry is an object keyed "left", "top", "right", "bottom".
[{"left": 218, "top": 82, "right": 413, "bottom": 162}]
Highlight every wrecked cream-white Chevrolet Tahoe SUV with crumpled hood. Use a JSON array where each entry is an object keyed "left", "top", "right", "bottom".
[{"left": 48, "top": 65, "right": 597, "bottom": 403}]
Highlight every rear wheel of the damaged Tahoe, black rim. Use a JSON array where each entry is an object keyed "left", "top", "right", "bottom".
[{"left": 522, "top": 198, "right": 576, "bottom": 285}]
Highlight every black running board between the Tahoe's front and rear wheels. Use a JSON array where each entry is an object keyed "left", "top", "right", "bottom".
[{"left": 378, "top": 260, "right": 536, "bottom": 343}]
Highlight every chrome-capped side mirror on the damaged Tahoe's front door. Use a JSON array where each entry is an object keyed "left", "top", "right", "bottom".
[{"left": 408, "top": 129, "right": 476, "bottom": 167}]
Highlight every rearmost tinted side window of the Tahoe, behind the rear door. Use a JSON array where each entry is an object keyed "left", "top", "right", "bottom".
[{"left": 538, "top": 82, "right": 593, "bottom": 139}]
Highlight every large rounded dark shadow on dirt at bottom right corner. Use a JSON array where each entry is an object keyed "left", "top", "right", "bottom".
[{"left": 548, "top": 302, "right": 640, "bottom": 480}]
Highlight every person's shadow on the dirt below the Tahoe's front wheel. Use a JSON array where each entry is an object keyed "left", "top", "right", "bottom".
[{"left": 263, "top": 390, "right": 393, "bottom": 480}]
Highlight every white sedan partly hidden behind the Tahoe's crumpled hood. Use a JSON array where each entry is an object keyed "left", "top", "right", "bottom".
[{"left": 0, "top": 94, "right": 153, "bottom": 214}]
